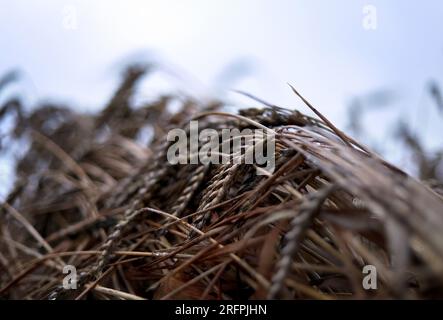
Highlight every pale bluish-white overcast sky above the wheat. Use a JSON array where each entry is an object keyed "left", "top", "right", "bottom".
[{"left": 0, "top": 0, "right": 443, "bottom": 196}]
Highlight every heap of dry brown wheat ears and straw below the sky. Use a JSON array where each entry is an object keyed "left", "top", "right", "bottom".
[{"left": 0, "top": 67, "right": 443, "bottom": 299}]
